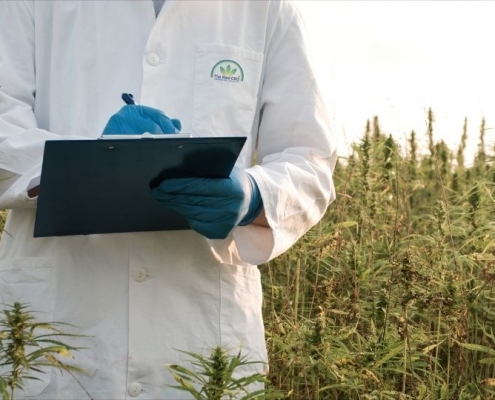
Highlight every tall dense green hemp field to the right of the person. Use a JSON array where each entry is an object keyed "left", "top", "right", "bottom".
[{"left": 0, "top": 110, "right": 495, "bottom": 400}]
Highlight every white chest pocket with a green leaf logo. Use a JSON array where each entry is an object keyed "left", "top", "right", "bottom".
[{"left": 192, "top": 43, "right": 263, "bottom": 136}]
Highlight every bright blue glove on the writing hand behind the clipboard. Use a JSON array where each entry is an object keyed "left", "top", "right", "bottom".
[{"left": 103, "top": 104, "right": 182, "bottom": 135}]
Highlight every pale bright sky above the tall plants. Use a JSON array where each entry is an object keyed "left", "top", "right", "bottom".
[{"left": 296, "top": 0, "right": 495, "bottom": 164}]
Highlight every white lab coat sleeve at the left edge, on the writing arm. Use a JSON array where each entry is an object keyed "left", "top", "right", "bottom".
[{"left": 0, "top": 0, "right": 80, "bottom": 209}]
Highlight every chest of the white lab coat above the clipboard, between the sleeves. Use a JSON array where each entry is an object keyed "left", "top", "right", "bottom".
[{"left": 34, "top": 0, "right": 280, "bottom": 166}]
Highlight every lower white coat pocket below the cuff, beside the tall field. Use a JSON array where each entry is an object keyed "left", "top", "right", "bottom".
[{"left": 220, "top": 264, "right": 267, "bottom": 373}]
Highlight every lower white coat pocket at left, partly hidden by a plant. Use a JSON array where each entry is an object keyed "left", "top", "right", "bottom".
[{"left": 0, "top": 257, "right": 55, "bottom": 398}]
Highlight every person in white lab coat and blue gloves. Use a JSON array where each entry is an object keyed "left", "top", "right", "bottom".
[{"left": 0, "top": 0, "right": 336, "bottom": 400}]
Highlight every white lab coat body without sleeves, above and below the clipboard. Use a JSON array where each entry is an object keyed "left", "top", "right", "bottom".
[{"left": 0, "top": 0, "right": 298, "bottom": 398}]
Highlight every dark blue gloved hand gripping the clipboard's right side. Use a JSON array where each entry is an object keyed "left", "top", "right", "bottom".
[{"left": 151, "top": 167, "right": 263, "bottom": 239}]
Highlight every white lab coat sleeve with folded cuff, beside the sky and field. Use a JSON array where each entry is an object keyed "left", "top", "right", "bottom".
[{"left": 233, "top": 5, "right": 337, "bottom": 265}]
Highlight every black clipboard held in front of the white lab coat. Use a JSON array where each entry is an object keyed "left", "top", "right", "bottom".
[{"left": 34, "top": 136, "right": 246, "bottom": 237}]
